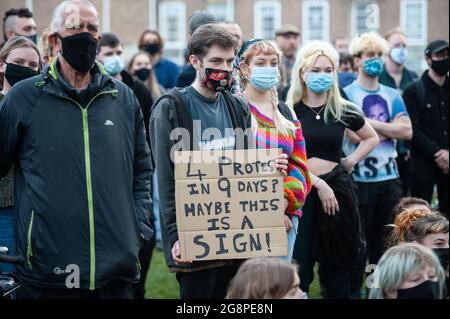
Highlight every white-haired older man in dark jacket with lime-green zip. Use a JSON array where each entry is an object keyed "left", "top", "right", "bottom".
[{"left": 0, "top": 0, "right": 153, "bottom": 299}]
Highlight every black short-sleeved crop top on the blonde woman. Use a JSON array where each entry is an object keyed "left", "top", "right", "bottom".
[{"left": 294, "top": 102, "right": 365, "bottom": 163}]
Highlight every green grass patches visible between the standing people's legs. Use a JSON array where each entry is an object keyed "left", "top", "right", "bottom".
[{"left": 145, "top": 249, "right": 321, "bottom": 299}]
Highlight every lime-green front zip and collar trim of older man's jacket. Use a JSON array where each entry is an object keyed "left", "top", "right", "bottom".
[{"left": 55, "top": 90, "right": 119, "bottom": 290}]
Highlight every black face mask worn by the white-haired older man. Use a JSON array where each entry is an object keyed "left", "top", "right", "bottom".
[{"left": 57, "top": 32, "right": 97, "bottom": 72}]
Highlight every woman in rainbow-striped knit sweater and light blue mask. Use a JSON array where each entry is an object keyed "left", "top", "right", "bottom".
[{"left": 238, "top": 40, "right": 311, "bottom": 261}]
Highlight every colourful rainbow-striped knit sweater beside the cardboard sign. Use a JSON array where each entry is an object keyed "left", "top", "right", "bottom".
[{"left": 249, "top": 103, "right": 312, "bottom": 217}]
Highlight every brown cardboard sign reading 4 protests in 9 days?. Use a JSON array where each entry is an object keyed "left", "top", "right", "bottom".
[{"left": 175, "top": 149, "right": 288, "bottom": 261}]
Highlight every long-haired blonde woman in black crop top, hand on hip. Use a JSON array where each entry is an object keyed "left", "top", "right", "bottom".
[{"left": 287, "top": 42, "right": 379, "bottom": 298}]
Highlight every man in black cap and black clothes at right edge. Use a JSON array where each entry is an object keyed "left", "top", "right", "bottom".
[{"left": 403, "top": 40, "right": 449, "bottom": 216}]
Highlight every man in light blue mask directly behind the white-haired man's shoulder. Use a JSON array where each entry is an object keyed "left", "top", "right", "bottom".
[{"left": 97, "top": 33, "right": 156, "bottom": 299}]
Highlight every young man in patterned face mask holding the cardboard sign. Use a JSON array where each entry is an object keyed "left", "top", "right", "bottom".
[{"left": 150, "top": 24, "right": 288, "bottom": 299}]
